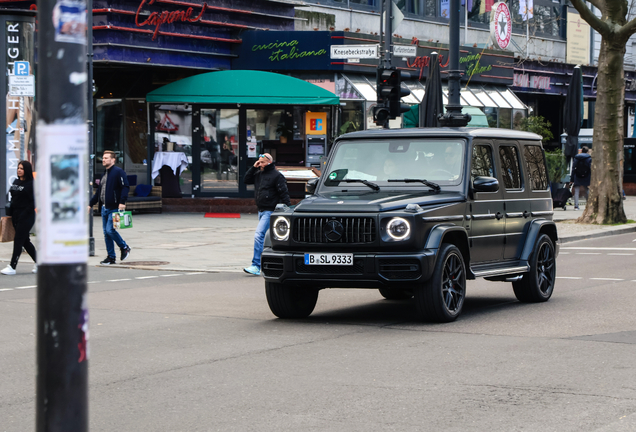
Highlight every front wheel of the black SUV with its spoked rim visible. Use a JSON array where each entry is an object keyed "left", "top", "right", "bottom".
[{"left": 415, "top": 243, "right": 466, "bottom": 322}]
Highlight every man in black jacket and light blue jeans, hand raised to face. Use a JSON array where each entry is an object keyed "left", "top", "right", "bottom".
[{"left": 243, "top": 153, "right": 291, "bottom": 276}]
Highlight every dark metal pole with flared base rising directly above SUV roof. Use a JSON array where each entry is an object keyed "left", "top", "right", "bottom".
[{"left": 439, "top": 0, "right": 471, "bottom": 127}]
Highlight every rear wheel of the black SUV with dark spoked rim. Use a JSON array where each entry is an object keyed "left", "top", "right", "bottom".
[{"left": 512, "top": 234, "right": 556, "bottom": 303}]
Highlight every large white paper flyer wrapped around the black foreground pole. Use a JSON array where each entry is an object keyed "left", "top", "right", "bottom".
[{"left": 36, "top": 123, "right": 89, "bottom": 264}]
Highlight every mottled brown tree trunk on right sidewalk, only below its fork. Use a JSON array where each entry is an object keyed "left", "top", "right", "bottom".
[{"left": 577, "top": 35, "right": 627, "bottom": 224}]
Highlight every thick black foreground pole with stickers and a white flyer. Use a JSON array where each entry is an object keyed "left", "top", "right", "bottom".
[{"left": 36, "top": 0, "right": 89, "bottom": 432}]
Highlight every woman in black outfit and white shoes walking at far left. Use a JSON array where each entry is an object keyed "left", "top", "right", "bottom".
[{"left": 0, "top": 161, "right": 38, "bottom": 275}]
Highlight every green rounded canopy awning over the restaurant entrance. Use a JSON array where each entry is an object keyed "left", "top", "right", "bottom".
[{"left": 146, "top": 70, "right": 340, "bottom": 105}]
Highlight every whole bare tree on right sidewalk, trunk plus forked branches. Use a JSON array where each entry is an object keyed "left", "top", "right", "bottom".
[{"left": 570, "top": 0, "right": 636, "bottom": 224}]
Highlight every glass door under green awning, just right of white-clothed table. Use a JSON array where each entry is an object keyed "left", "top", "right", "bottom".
[{"left": 194, "top": 108, "right": 241, "bottom": 196}]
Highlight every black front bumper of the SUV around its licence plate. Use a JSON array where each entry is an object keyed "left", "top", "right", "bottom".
[{"left": 261, "top": 248, "right": 437, "bottom": 288}]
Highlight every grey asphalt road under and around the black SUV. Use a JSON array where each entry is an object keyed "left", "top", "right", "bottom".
[{"left": 0, "top": 234, "right": 636, "bottom": 432}]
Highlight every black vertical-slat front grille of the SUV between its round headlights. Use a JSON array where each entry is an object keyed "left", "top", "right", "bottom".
[{"left": 292, "top": 216, "right": 376, "bottom": 244}]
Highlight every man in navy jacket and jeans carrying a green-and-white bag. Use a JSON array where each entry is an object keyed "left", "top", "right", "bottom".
[{"left": 89, "top": 150, "right": 130, "bottom": 265}]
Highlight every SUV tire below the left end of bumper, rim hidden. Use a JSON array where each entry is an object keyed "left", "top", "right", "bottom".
[{"left": 265, "top": 282, "right": 318, "bottom": 318}]
